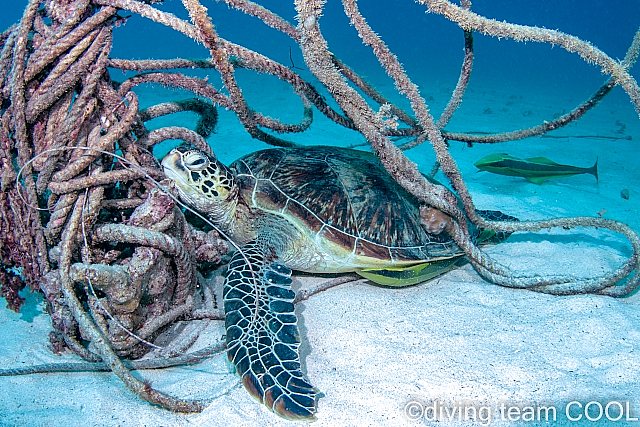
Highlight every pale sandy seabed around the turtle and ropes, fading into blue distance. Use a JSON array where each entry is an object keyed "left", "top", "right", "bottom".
[{"left": 0, "top": 46, "right": 640, "bottom": 427}]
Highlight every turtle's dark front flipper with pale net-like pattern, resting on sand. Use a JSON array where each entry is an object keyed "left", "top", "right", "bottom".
[{"left": 223, "top": 241, "right": 318, "bottom": 421}]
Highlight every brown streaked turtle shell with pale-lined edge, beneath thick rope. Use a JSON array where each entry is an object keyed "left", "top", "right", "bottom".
[{"left": 230, "top": 146, "right": 461, "bottom": 268}]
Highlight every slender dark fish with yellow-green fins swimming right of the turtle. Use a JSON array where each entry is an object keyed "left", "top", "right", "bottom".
[{"left": 476, "top": 153, "right": 598, "bottom": 185}]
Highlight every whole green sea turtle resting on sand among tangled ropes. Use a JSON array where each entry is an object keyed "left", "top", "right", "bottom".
[{"left": 162, "top": 146, "right": 516, "bottom": 420}]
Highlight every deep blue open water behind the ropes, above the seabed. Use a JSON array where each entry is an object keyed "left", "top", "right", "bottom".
[{"left": 0, "top": 0, "right": 640, "bottom": 172}]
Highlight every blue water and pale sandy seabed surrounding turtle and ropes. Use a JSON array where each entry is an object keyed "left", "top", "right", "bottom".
[{"left": 0, "top": 0, "right": 640, "bottom": 427}]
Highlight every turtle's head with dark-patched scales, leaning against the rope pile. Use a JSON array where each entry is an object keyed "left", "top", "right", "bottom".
[{"left": 162, "top": 145, "right": 238, "bottom": 222}]
